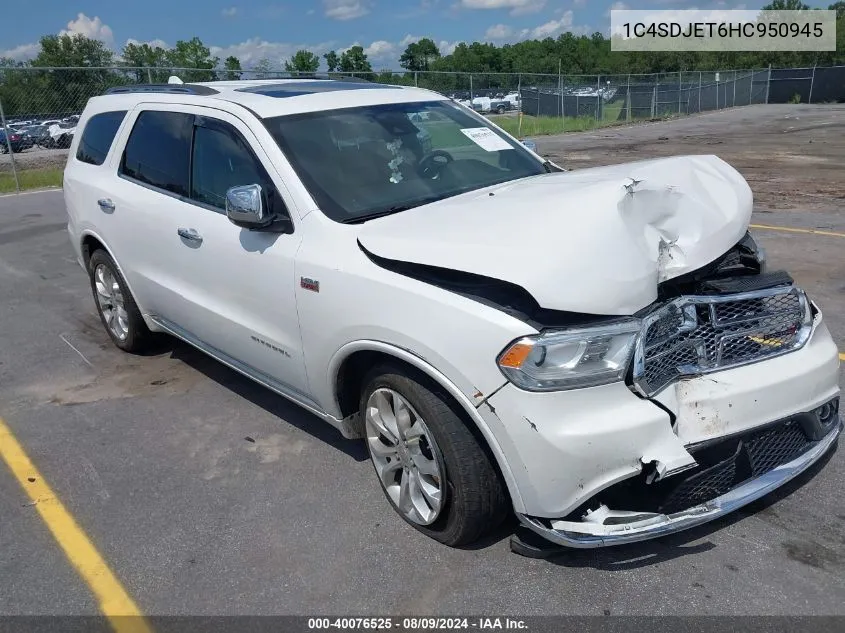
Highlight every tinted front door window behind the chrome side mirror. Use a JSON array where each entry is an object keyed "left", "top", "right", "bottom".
[{"left": 190, "top": 121, "right": 275, "bottom": 211}]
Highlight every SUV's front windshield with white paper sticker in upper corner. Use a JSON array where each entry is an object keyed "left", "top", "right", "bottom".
[{"left": 265, "top": 101, "right": 545, "bottom": 223}]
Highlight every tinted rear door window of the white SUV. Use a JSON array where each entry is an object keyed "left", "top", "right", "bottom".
[{"left": 120, "top": 110, "right": 194, "bottom": 196}]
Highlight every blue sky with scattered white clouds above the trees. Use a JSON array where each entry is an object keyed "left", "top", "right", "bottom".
[{"left": 0, "top": 0, "right": 833, "bottom": 70}]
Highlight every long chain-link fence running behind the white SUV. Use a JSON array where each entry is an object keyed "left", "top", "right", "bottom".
[{"left": 0, "top": 66, "right": 845, "bottom": 189}]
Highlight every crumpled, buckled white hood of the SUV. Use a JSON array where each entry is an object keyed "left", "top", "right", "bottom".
[{"left": 358, "top": 156, "right": 752, "bottom": 315}]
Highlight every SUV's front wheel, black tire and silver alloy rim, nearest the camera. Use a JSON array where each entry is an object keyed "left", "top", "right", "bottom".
[{"left": 361, "top": 366, "right": 509, "bottom": 546}]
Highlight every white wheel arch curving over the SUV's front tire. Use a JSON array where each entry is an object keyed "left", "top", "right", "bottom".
[{"left": 328, "top": 340, "right": 523, "bottom": 508}]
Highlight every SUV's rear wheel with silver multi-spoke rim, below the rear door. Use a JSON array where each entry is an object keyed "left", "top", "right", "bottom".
[{"left": 88, "top": 249, "right": 153, "bottom": 353}]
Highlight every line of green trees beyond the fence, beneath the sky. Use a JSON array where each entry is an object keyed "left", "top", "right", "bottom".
[{"left": 0, "top": 0, "right": 845, "bottom": 115}]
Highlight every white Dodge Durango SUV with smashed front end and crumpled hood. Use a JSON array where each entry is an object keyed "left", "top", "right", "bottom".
[{"left": 64, "top": 79, "right": 842, "bottom": 547}]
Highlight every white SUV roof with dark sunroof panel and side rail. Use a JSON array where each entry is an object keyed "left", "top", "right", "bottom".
[{"left": 99, "top": 79, "right": 447, "bottom": 118}]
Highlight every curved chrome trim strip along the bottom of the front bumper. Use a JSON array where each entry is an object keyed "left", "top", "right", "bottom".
[{"left": 517, "top": 420, "right": 843, "bottom": 549}]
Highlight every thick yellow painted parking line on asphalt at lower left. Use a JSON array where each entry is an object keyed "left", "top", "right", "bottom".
[{"left": 0, "top": 418, "right": 152, "bottom": 633}]
